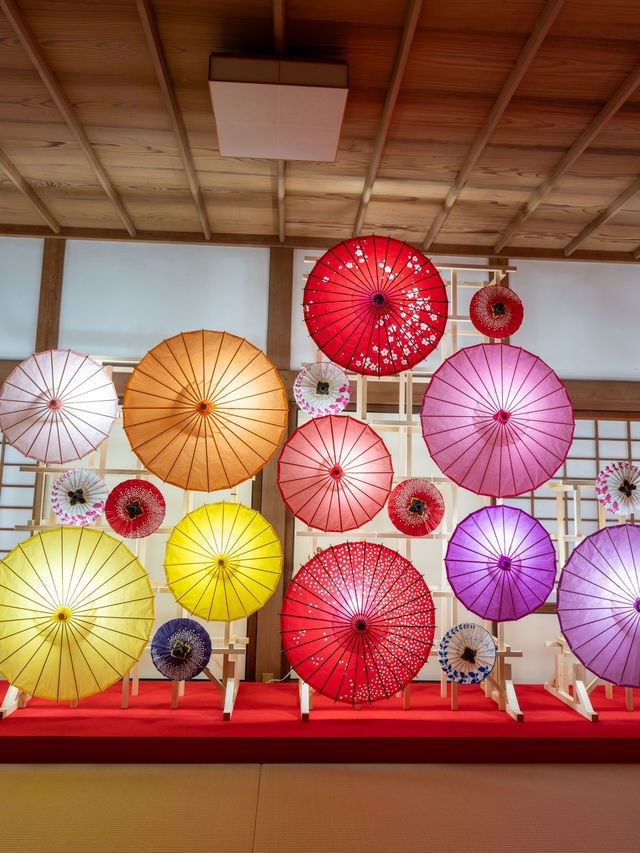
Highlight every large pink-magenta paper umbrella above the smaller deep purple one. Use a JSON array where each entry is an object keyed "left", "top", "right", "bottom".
[{"left": 421, "top": 344, "right": 574, "bottom": 498}]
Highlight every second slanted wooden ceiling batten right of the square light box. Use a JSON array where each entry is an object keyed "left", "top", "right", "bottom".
[{"left": 422, "top": 0, "right": 565, "bottom": 251}]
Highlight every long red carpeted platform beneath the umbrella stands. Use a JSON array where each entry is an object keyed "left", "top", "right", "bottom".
[{"left": 0, "top": 681, "right": 640, "bottom": 763}]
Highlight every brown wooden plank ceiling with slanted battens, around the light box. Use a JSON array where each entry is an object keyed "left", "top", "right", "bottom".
[{"left": 0, "top": 0, "right": 640, "bottom": 261}]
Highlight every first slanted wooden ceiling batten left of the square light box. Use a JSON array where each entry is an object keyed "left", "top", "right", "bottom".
[{"left": 136, "top": 0, "right": 211, "bottom": 240}]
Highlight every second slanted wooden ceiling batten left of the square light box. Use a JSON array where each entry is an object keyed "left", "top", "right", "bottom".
[{"left": 0, "top": 0, "right": 136, "bottom": 237}]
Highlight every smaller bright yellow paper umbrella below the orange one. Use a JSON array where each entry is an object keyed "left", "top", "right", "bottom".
[{"left": 164, "top": 503, "right": 282, "bottom": 622}]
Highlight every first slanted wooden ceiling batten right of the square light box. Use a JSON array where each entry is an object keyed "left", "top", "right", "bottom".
[{"left": 353, "top": 0, "right": 422, "bottom": 237}]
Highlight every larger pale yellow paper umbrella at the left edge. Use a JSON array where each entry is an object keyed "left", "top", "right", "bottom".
[{"left": 0, "top": 527, "right": 154, "bottom": 701}]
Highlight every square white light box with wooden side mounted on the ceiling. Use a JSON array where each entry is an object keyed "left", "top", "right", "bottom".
[{"left": 209, "top": 54, "right": 349, "bottom": 162}]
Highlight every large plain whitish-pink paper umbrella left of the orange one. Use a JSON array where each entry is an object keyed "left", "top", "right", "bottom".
[{"left": 0, "top": 350, "right": 118, "bottom": 464}]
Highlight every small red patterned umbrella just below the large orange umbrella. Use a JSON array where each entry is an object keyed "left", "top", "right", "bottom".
[{"left": 105, "top": 480, "right": 166, "bottom": 539}]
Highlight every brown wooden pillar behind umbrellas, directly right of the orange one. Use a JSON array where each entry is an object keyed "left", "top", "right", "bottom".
[{"left": 254, "top": 247, "right": 296, "bottom": 681}]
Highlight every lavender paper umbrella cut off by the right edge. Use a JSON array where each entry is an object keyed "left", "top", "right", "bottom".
[{"left": 558, "top": 524, "right": 640, "bottom": 687}]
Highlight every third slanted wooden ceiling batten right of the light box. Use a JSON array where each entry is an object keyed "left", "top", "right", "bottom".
[{"left": 493, "top": 64, "right": 640, "bottom": 254}]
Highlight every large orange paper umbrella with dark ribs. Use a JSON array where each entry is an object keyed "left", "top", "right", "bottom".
[{"left": 122, "top": 330, "right": 287, "bottom": 492}]
